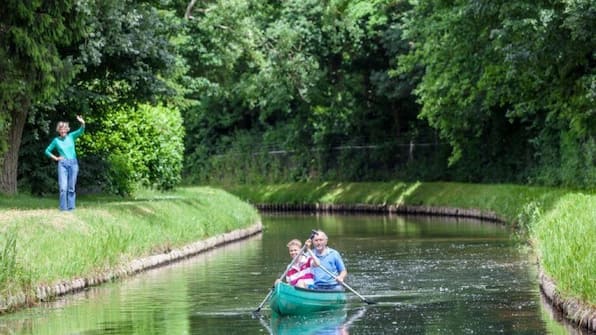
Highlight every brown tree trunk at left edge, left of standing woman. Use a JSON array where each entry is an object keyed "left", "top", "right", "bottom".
[{"left": 0, "top": 98, "right": 31, "bottom": 194}]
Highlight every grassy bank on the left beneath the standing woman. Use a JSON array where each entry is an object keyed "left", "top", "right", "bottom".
[{"left": 0, "top": 187, "right": 258, "bottom": 306}]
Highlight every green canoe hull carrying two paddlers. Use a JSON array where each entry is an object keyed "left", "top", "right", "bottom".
[{"left": 269, "top": 282, "right": 346, "bottom": 315}]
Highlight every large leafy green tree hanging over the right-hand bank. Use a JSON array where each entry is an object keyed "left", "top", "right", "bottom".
[{"left": 400, "top": 1, "right": 596, "bottom": 186}]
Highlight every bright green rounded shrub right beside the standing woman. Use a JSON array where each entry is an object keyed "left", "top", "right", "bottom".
[{"left": 81, "top": 105, "right": 184, "bottom": 195}]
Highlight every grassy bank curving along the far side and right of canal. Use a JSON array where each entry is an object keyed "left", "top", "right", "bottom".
[{"left": 226, "top": 182, "right": 596, "bottom": 305}]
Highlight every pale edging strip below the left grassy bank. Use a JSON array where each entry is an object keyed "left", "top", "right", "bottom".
[{"left": 0, "top": 220, "right": 263, "bottom": 313}]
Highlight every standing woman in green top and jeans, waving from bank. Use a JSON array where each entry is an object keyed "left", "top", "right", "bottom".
[{"left": 45, "top": 115, "right": 85, "bottom": 211}]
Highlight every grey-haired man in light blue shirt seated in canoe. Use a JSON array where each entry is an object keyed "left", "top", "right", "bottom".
[{"left": 312, "top": 230, "right": 348, "bottom": 290}]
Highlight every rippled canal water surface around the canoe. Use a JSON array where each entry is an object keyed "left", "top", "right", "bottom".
[{"left": 0, "top": 214, "right": 581, "bottom": 335}]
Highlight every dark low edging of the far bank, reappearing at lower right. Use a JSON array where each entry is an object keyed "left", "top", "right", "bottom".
[{"left": 253, "top": 203, "right": 596, "bottom": 331}]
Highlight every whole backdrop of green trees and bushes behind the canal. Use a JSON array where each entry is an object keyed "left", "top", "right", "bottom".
[{"left": 0, "top": 0, "right": 596, "bottom": 194}]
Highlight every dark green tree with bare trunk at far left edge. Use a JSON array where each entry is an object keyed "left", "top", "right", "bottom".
[{"left": 0, "top": 0, "right": 85, "bottom": 193}]
